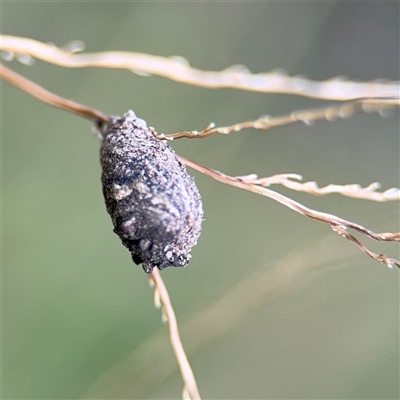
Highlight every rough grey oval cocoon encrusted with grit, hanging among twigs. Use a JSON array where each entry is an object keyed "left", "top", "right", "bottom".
[{"left": 100, "top": 111, "right": 203, "bottom": 273}]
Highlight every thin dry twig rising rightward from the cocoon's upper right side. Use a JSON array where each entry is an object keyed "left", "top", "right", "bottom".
[{"left": 162, "top": 98, "right": 400, "bottom": 140}]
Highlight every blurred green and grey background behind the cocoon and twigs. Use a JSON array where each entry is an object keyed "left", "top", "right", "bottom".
[{"left": 1, "top": 2, "right": 399, "bottom": 399}]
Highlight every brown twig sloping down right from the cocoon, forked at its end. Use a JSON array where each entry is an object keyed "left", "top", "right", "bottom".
[{"left": 178, "top": 156, "right": 400, "bottom": 268}]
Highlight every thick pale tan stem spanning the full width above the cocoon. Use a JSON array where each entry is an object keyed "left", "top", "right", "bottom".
[{"left": 0, "top": 35, "right": 399, "bottom": 101}]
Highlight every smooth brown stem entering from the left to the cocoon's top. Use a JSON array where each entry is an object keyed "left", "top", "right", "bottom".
[{"left": 0, "top": 64, "right": 110, "bottom": 124}]
